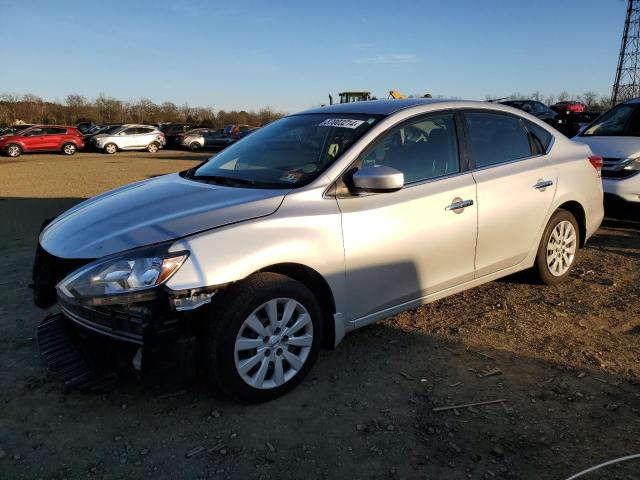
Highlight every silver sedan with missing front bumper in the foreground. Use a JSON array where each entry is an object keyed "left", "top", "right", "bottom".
[{"left": 34, "top": 99, "right": 603, "bottom": 402}]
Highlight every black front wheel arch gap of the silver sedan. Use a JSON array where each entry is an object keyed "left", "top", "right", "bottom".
[{"left": 258, "top": 263, "right": 336, "bottom": 348}]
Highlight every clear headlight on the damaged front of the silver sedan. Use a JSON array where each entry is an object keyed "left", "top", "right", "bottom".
[{"left": 57, "top": 245, "right": 189, "bottom": 305}]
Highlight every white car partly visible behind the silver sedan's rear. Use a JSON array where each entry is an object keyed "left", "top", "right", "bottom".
[{"left": 573, "top": 98, "right": 640, "bottom": 203}]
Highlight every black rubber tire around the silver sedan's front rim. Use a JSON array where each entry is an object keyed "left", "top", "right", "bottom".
[{"left": 205, "top": 272, "right": 322, "bottom": 403}]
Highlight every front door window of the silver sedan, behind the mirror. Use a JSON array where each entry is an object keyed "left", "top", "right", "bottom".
[{"left": 363, "top": 113, "right": 460, "bottom": 185}]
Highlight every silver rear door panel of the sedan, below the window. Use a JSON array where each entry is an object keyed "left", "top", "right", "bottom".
[{"left": 473, "top": 156, "right": 557, "bottom": 277}]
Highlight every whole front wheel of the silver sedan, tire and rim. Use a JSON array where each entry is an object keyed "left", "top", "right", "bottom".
[{"left": 207, "top": 273, "right": 322, "bottom": 403}]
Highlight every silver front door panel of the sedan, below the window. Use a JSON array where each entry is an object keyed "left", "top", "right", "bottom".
[{"left": 338, "top": 173, "right": 477, "bottom": 320}]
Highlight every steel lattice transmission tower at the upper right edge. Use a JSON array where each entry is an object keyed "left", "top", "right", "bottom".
[{"left": 611, "top": 0, "right": 640, "bottom": 105}]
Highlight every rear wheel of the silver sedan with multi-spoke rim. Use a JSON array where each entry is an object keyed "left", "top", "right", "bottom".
[{"left": 535, "top": 209, "right": 580, "bottom": 285}]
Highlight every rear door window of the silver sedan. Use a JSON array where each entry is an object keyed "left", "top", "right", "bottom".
[{"left": 465, "top": 113, "right": 531, "bottom": 168}]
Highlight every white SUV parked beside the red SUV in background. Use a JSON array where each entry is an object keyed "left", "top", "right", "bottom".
[{"left": 91, "top": 125, "right": 166, "bottom": 153}]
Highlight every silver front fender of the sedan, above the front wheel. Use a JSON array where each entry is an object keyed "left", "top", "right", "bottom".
[{"left": 166, "top": 190, "right": 345, "bottom": 318}]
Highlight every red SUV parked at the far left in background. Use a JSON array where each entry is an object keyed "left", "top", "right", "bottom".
[{"left": 0, "top": 125, "right": 84, "bottom": 157}]
